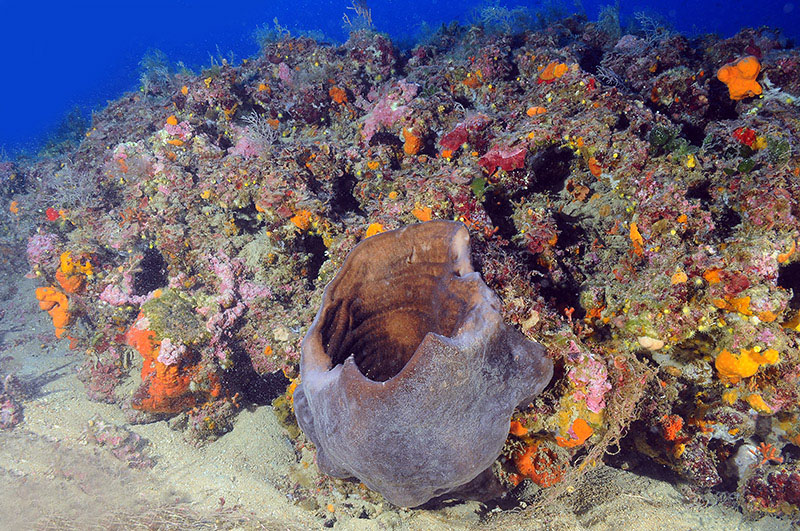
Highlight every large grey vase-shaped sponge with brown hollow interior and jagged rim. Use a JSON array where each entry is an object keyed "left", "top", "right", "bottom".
[{"left": 294, "top": 221, "right": 553, "bottom": 507}]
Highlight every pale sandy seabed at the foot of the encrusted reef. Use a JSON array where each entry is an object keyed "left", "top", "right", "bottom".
[{"left": 0, "top": 279, "right": 791, "bottom": 531}]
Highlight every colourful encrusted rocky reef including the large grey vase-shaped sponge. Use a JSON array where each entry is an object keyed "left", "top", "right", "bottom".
[{"left": 0, "top": 6, "right": 800, "bottom": 518}]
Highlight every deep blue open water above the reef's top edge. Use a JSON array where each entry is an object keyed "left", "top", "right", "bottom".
[{"left": 0, "top": 0, "right": 800, "bottom": 159}]
